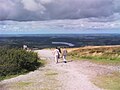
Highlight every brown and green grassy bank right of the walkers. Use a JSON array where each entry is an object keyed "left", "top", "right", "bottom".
[{"left": 69, "top": 46, "right": 120, "bottom": 64}]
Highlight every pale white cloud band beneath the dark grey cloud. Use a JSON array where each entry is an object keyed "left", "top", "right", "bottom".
[{"left": 0, "top": 19, "right": 120, "bottom": 32}]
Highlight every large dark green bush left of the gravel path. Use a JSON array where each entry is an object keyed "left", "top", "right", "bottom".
[{"left": 0, "top": 48, "right": 41, "bottom": 79}]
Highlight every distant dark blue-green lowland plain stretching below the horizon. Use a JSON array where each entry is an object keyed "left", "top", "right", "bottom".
[{"left": 0, "top": 34, "right": 120, "bottom": 49}]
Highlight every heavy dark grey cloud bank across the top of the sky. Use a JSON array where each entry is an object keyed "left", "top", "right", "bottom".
[{"left": 0, "top": 0, "right": 120, "bottom": 21}]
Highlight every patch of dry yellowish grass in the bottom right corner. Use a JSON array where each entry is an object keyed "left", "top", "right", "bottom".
[{"left": 92, "top": 72, "right": 120, "bottom": 90}]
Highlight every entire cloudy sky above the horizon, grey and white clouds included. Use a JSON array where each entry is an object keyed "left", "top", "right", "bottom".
[{"left": 0, "top": 0, "right": 120, "bottom": 34}]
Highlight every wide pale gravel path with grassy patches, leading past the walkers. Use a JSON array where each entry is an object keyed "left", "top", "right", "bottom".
[{"left": 0, "top": 50, "right": 119, "bottom": 90}]
